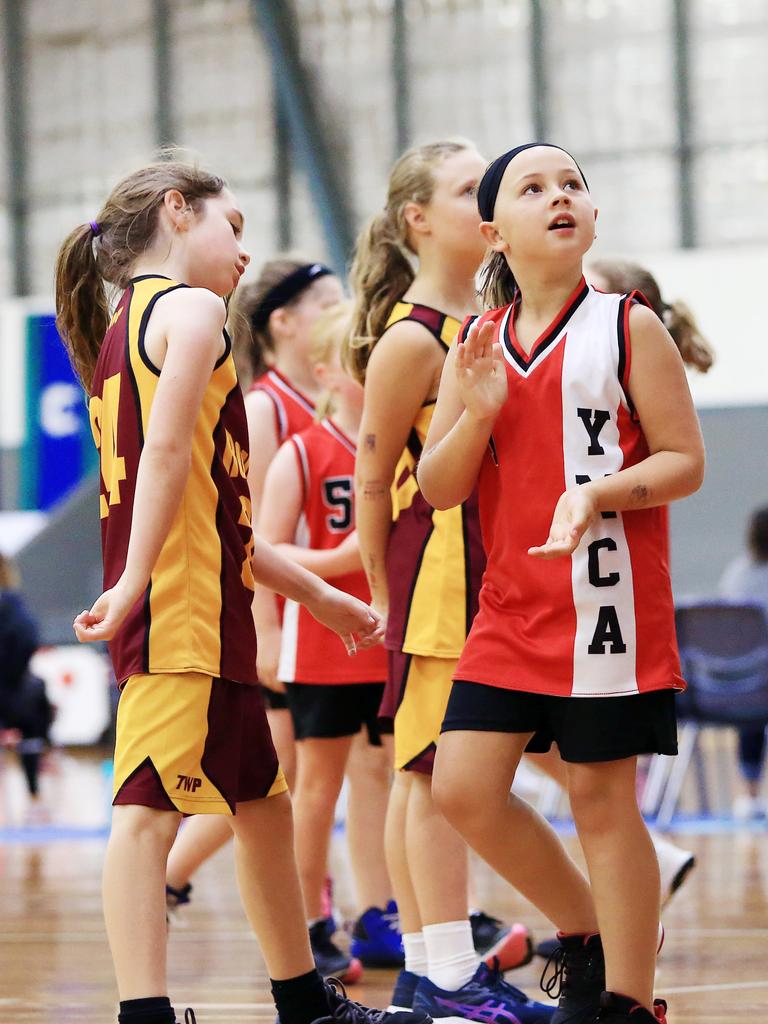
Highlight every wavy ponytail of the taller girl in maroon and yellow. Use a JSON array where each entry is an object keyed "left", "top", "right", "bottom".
[{"left": 341, "top": 211, "right": 416, "bottom": 383}]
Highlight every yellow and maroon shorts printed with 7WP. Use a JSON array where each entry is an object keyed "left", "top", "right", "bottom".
[{"left": 113, "top": 672, "right": 287, "bottom": 814}]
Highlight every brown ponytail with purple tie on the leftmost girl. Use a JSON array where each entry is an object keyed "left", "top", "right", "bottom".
[{"left": 55, "top": 224, "right": 110, "bottom": 391}]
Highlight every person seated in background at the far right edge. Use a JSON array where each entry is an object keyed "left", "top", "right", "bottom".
[{"left": 720, "top": 507, "right": 768, "bottom": 819}]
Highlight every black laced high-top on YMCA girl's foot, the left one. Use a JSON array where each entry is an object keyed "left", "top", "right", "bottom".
[{"left": 542, "top": 934, "right": 605, "bottom": 1024}]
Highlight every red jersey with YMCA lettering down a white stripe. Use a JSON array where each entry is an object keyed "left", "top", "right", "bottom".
[{"left": 455, "top": 279, "right": 684, "bottom": 697}]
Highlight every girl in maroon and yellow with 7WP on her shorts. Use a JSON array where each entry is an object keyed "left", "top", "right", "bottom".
[{"left": 51, "top": 162, "right": 405, "bottom": 1024}]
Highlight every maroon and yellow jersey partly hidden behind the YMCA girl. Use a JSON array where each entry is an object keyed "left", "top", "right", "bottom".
[{"left": 386, "top": 302, "right": 485, "bottom": 658}]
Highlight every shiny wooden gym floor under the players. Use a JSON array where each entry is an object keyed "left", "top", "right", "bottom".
[{"left": 0, "top": 755, "right": 768, "bottom": 1024}]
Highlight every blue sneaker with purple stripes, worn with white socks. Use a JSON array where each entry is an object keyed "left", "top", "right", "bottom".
[{"left": 414, "top": 964, "right": 557, "bottom": 1024}]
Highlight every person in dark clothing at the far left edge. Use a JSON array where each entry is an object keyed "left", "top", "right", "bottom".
[{"left": 0, "top": 554, "right": 53, "bottom": 797}]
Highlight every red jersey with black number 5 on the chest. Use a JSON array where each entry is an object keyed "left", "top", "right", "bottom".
[{"left": 278, "top": 419, "right": 387, "bottom": 683}]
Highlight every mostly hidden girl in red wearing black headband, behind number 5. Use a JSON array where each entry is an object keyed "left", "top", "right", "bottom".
[{"left": 167, "top": 256, "right": 343, "bottom": 912}]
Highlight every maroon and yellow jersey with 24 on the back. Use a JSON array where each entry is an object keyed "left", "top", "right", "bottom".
[{"left": 89, "top": 274, "right": 257, "bottom": 683}]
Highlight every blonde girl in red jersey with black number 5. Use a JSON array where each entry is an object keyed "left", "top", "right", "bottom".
[{"left": 258, "top": 303, "right": 402, "bottom": 981}]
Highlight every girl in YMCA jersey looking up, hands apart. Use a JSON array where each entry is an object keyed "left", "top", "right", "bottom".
[{"left": 419, "top": 143, "right": 703, "bottom": 1024}]
